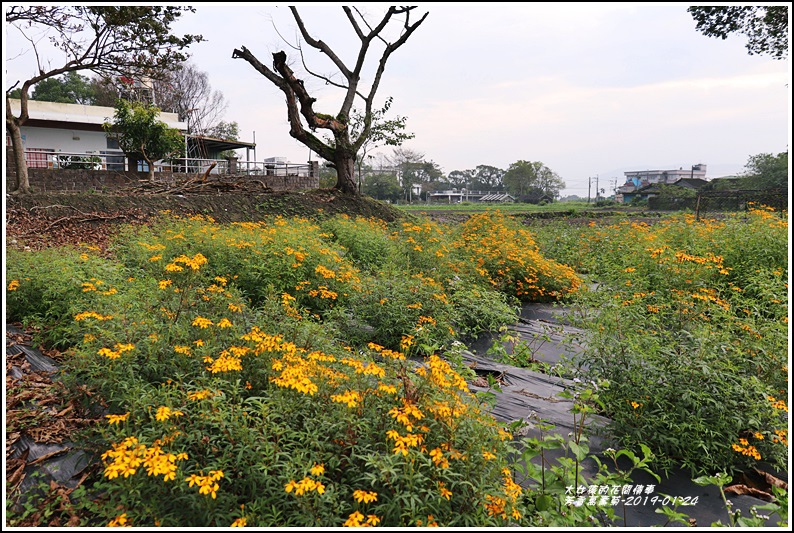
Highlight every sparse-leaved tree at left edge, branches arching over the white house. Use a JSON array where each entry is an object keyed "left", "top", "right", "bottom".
[{"left": 6, "top": 5, "right": 203, "bottom": 193}]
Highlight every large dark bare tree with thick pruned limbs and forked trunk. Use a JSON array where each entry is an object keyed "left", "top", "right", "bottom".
[{"left": 232, "top": 6, "right": 428, "bottom": 194}]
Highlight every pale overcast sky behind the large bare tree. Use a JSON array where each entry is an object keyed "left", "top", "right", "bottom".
[{"left": 6, "top": 3, "right": 791, "bottom": 196}]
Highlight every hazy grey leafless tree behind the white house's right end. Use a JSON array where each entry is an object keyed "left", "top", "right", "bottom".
[{"left": 154, "top": 63, "right": 229, "bottom": 135}]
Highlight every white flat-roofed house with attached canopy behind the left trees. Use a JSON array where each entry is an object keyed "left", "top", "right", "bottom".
[{"left": 6, "top": 99, "right": 256, "bottom": 172}]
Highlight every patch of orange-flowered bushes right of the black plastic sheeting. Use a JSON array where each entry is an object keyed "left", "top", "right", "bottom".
[{"left": 536, "top": 206, "right": 789, "bottom": 475}]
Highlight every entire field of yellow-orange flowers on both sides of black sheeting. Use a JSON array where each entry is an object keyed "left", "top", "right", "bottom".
[{"left": 6, "top": 205, "right": 788, "bottom": 527}]
